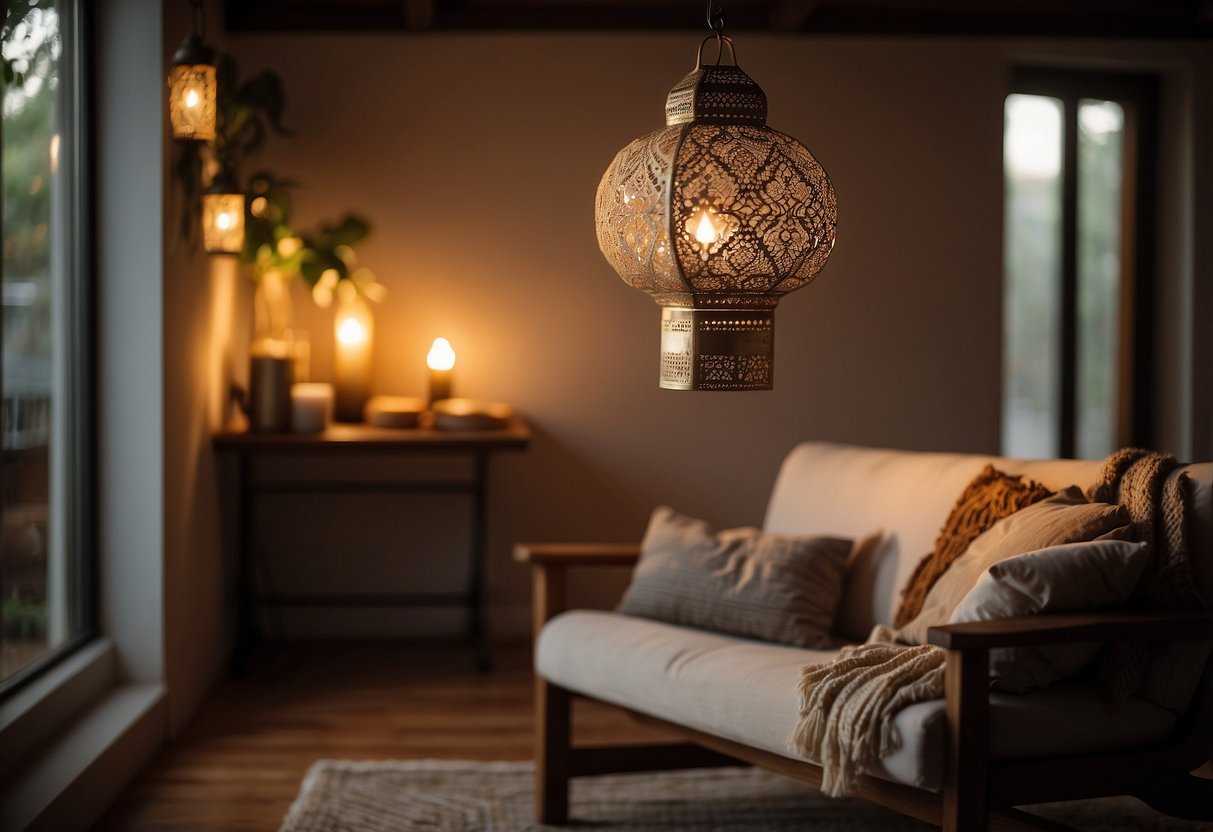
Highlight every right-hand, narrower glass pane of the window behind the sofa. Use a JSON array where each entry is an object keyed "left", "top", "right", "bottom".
[{"left": 1075, "top": 98, "right": 1124, "bottom": 458}]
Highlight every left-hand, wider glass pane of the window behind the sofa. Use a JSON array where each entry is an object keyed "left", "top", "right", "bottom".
[{"left": 1002, "top": 95, "right": 1063, "bottom": 457}]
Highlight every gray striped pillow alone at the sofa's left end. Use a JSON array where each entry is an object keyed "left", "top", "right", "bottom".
[{"left": 619, "top": 506, "right": 852, "bottom": 648}]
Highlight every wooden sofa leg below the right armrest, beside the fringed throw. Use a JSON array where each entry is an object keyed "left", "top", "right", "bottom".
[{"left": 943, "top": 650, "right": 990, "bottom": 832}]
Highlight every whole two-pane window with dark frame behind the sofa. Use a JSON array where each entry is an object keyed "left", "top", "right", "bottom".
[{"left": 1002, "top": 72, "right": 1155, "bottom": 458}]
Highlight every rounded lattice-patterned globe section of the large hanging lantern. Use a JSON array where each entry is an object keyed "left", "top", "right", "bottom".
[{"left": 597, "top": 124, "right": 838, "bottom": 307}]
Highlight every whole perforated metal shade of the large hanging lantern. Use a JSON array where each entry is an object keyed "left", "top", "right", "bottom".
[{"left": 596, "top": 48, "right": 837, "bottom": 391}]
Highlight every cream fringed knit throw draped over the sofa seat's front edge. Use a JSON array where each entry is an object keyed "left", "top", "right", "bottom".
[{"left": 788, "top": 625, "right": 947, "bottom": 797}]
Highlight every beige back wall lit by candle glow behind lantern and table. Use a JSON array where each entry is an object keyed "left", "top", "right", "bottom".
[{"left": 177, "top": 34, "right": 1207, "bottom": 640}]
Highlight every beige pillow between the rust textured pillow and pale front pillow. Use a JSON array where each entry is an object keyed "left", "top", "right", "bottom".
[{"left": 899, "top": 485, "right": 1129, "bottom": 644}]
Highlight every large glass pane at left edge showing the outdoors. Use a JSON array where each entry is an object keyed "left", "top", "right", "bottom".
[{"left": 0, "top": 0, "right": 90, "bottom": 690}]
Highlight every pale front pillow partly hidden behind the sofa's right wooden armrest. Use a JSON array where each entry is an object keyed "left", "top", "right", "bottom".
[{"left": 949, "top": 540, "right": 1149, "bottom": 693}]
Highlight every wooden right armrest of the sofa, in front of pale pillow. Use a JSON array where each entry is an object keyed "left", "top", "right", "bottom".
[{"left": 927, "top": 610, "right": 1213, "bottom": 650}]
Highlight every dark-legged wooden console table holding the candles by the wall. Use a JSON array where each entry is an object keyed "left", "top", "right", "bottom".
[{"left": 212, "top": 418, "right": 530, "bottom": 676}]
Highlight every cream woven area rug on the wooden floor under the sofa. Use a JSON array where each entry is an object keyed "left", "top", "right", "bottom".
[{"left": 280, "top": 760, "right": 1208, "bottom": 832}]
